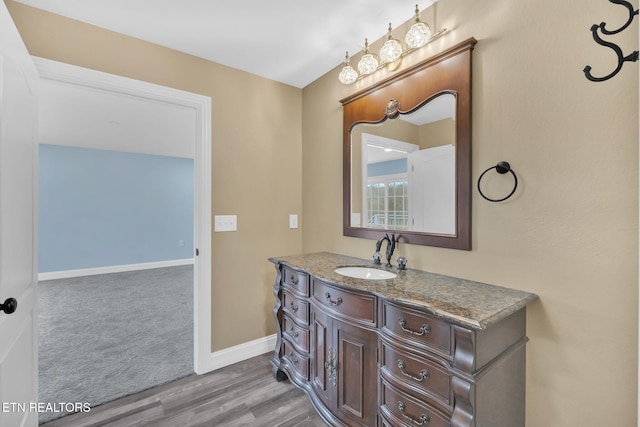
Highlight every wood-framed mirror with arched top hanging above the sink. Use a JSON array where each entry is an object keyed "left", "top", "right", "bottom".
[{"left": 340, "top": 38, "right": 476, "bottom": 250}]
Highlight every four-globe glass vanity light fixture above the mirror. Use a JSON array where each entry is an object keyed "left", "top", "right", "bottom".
[{"left": 338, "top": 4, "right": 447, "bottom": 85}]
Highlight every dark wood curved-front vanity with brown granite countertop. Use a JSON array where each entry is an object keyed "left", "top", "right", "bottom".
[{"left": 269, "top": 252, "right": 537, "bottom": 427}]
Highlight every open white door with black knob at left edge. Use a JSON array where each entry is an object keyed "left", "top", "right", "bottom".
[{"left": 0, "top": 1, "right": 38, "bottom": 427}]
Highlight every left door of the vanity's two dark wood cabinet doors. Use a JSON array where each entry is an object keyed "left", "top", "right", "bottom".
[{"left": 311, "top": 310, "right": 336, "bottom": 408}]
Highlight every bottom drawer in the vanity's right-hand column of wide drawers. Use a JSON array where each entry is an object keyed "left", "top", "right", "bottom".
[{"left": 380, "top": 379, "right": 451, "bottom": 427}]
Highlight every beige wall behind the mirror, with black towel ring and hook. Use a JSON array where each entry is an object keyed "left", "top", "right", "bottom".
[{"left": 302, "top": 0, "right": 639, "bottom": 427}]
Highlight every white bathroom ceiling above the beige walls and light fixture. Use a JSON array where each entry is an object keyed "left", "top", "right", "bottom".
[{"left": 17, "top": 0, "right": 436, "bottom": 88}]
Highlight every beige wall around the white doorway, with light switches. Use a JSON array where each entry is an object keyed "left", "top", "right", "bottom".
[{"left": 5, "top": 0, "right": 302, "bottom": 351}]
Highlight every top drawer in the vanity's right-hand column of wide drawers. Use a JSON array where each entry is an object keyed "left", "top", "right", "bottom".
[{"left": 382, "top": 301, "right": 452, "bottom": 358}]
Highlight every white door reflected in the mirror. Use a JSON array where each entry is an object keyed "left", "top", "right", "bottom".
[{"left": 407, "top": 144, "right": 456, "bottom": 234}]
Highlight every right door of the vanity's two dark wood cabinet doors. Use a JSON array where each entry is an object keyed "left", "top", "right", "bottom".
[{"left": 333, "top": 320, "right": 378, "bottom": 426}]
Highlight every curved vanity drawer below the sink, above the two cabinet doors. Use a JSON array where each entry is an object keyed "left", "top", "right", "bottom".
[{"left": 313, "top": 278, "right": 377, "bottom": 325}]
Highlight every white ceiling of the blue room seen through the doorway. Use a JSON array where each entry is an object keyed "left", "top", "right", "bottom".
[{"left": 38, "top": 79, "right": 197, "bottom": 158}]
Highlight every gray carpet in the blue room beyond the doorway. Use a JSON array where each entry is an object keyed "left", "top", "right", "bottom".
[{"left": 38, "top": 265, "right": 194, "bottom": 422}]
